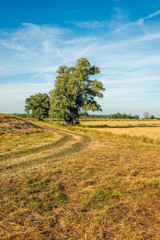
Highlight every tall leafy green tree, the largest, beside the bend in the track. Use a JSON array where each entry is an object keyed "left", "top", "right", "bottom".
[{"left": 50, "top": 58, "right": 105, "bottom": 125}]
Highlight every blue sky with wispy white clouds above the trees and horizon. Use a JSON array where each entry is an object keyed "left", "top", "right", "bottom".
[{"left": 0, "top": 0, "right": 160, "bottom": 117}]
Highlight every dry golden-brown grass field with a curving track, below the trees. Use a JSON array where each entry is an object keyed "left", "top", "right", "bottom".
[{"left": 0, "top": 114, "right": 160, "bottom": 240}]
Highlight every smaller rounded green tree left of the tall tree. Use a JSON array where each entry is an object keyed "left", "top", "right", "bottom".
[{"left": 25, "top": 93, "right": 50, "bottom": 121}]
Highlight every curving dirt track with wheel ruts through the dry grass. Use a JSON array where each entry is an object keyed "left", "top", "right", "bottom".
[{"left": 0, "top": 126, "right": 90, "bottom": 181}]
